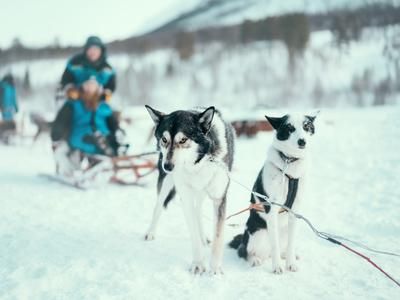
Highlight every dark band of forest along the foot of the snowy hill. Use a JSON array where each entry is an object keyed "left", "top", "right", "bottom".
[{"left": 0, "top": 5, "right": 400, "bottom": 64}]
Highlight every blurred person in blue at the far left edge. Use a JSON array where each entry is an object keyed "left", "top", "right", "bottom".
[{"left": 0, "top": 74, "right": 18, "bottom": 123}]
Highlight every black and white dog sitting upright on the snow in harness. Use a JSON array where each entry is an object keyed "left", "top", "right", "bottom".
[{"left": 229, "top": 114, "right": 316, "bottom": 274}]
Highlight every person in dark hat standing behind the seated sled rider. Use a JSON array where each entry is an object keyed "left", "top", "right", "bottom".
[{"left": 61, "top": 36, "right": 116, "bottom": 101}]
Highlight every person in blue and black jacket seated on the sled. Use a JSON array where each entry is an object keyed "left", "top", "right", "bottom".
[{"left": 51, "top": 78, "right": 121, "bottom": 176}]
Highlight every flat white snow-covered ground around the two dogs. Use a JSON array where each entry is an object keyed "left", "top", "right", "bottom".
[{"left": 0, "top": 107, "right": 400, "bottom": 300}]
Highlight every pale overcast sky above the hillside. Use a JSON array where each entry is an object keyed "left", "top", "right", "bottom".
[{"left": 0, "top": 0, "right": 199, "bottom": 48}]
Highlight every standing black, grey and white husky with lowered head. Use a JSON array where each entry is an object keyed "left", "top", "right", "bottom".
[{"left": 145, "top": 106, "right": 234, "bottom": 274}]
